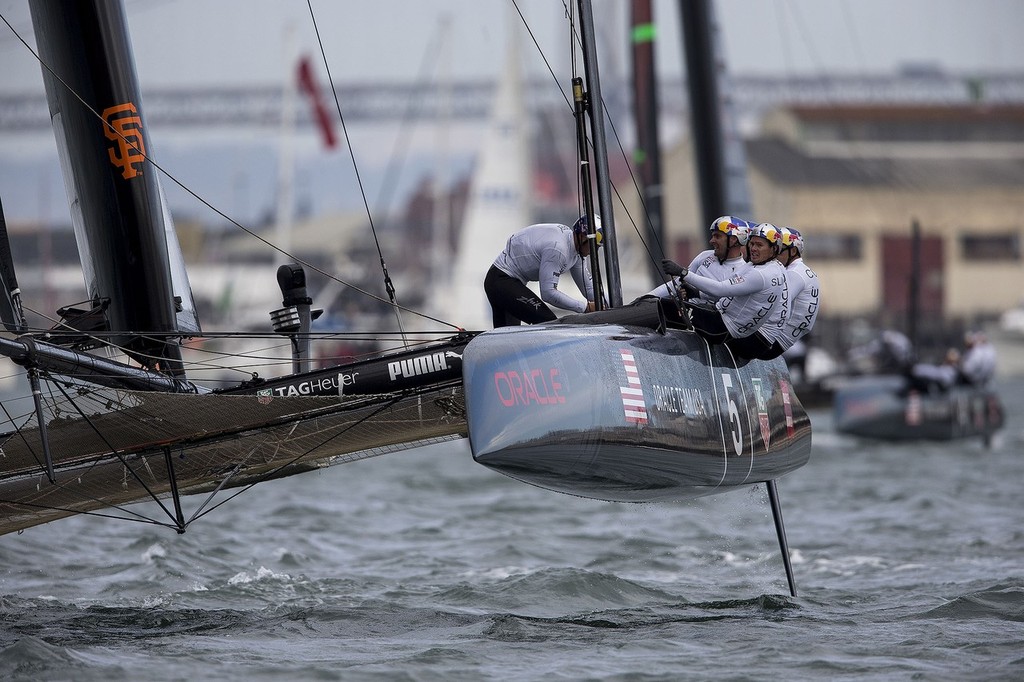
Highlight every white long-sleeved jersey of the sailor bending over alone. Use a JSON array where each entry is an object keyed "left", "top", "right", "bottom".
[{"left": 494, "top": 222, "right": 594, "bottom": 312}]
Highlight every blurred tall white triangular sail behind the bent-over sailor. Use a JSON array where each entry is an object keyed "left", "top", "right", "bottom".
[{"left": 434, "top": 23, "right": 531, "bottom": 330}]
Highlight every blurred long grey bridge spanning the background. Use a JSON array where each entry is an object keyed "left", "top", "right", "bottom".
[{"left": 6, "top": 71, "right": 1024, "bottom": 135}]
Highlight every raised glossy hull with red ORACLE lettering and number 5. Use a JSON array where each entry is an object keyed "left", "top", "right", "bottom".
[{"left": 464, "top": 325, "right": 811, "bottom": 502}]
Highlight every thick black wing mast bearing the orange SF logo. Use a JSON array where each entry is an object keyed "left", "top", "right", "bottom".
[{"left": 29, "top": 0, "right": 199, "bottom": 376}]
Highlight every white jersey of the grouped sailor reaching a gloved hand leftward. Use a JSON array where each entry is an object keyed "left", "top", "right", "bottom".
[{"left": 683, "top": 258, "right": 788, "bottom": 339}]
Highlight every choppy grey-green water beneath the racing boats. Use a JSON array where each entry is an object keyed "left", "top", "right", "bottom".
[{"left": 0, "top": 380, "right": 1024, "bottom": 680}]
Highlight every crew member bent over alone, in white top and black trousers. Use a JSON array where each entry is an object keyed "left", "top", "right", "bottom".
[{"left": 483, "top": 215, "right": 602, "bottom": 329}]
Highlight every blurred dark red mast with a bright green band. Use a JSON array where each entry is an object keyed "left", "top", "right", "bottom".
[{"left": 631, "top": 0, "right": 665, "bottom": 282}]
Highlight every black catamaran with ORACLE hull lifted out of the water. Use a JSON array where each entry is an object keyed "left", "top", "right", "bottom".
[{"left": 0, "top": 0, "right": 811, "bottom": 594}]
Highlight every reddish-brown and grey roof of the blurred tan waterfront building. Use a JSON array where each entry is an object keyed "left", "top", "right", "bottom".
[{"left": 746, "top": 104, "right": 1024, "bottom": 190}]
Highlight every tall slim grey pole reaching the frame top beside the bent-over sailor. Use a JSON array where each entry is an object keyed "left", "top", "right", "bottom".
[{"left": 578, "top": 0, "right": 623, "bottom": 308}]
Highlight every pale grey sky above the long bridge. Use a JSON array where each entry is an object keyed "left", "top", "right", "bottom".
[{"left": 0, "top": 0, "right": 1024, "bottom": 92}]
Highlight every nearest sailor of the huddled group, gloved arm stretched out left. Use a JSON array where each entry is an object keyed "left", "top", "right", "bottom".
[{"left": 662, "top": 222, "right": 788, "bottom": 358}]
